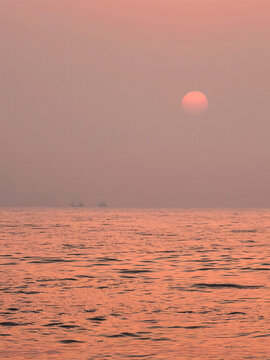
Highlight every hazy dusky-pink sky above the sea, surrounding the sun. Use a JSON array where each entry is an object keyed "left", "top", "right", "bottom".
[{"left": 0, "top": 0, "right": 270, "bottom": 207}]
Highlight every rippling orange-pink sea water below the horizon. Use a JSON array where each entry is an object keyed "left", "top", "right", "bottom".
[{"left": 0, "top": 208, "right": 270, "bottom": 360}]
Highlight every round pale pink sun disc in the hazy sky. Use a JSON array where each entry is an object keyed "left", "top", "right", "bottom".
[{"left": 182, "top": 91, "right": 208, "bottom": 115}]
